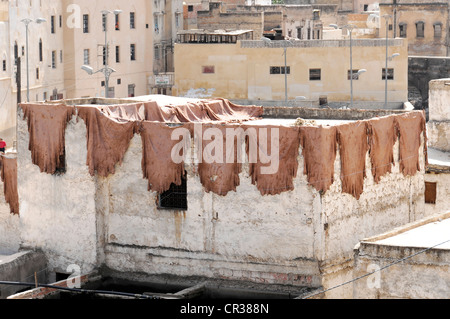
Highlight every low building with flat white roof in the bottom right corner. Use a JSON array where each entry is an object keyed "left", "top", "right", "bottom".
[{"left": 353, "top": 211, "right": 450, "bottom": 300}]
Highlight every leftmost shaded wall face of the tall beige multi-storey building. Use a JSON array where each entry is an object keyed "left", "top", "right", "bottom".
[{"left": 0, "top": 0, "right": 66, "bottom": 148}]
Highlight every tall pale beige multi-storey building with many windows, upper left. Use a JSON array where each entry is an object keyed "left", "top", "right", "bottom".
[{"left": 0, "top": 0, "right": 183, "bottom": 151}]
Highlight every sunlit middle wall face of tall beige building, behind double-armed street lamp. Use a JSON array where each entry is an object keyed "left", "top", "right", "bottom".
[{"left": 63, "top": 0, "right": 153, "bottom": 98}]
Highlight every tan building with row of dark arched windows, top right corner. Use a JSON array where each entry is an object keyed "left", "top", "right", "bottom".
[{"left": 380, "top": 0, "right": 450, "bottom": 56}]
